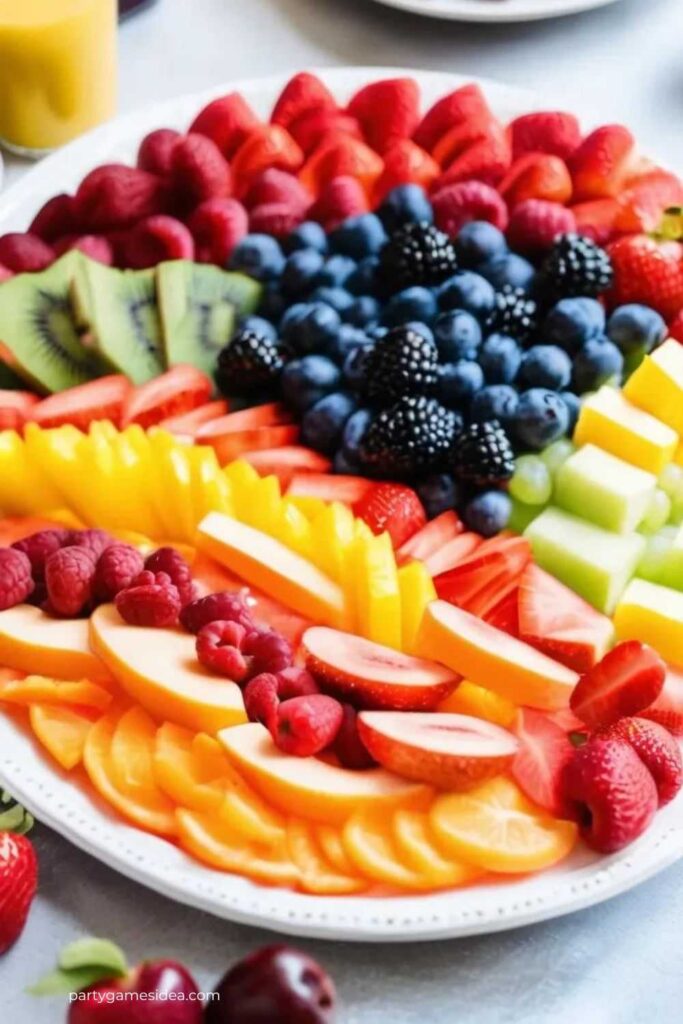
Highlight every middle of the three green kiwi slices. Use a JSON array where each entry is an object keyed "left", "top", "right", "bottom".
[{"left": 72, "top": 259, "right": 165, "bottom": 384}]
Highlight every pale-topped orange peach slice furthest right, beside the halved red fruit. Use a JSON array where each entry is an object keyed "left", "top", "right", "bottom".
[{"left": 418, "top": 601, "right": 579, "bottom": 711}]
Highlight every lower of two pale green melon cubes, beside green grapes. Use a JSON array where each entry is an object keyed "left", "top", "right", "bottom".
[{"left": 524, "top": 505, "right": 645, "bottom": 615}]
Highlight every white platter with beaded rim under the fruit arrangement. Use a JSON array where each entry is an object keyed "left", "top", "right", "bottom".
[{"left": 0, "top": 68, "right": 683, "bottom": 942}]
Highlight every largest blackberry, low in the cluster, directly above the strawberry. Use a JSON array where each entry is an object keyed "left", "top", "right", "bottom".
[{"left": 358, "top": 395, "right": 462, "bottom": 479}]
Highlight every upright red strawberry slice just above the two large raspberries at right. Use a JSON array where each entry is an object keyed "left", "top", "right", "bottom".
[{"left": 569, "top": 640, "right": 667, "bottom": 729}]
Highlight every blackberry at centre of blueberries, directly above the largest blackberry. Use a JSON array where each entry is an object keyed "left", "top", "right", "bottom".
[{"left": 364, "top": 325, "right": 438, "bottom": 406}]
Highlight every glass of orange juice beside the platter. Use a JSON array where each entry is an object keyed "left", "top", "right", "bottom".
[{"left": 0, "top": 0, "right": 117, "bottom": 156}]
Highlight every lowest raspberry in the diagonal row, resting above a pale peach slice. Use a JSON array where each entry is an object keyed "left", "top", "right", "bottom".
[{"left": 269, "top": 693, "right": 343, "bottom": 758}]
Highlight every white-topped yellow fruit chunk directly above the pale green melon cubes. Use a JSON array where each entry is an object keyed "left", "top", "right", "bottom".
[{"left": 573, "top": 385, "right": 678, "bottom": 476}]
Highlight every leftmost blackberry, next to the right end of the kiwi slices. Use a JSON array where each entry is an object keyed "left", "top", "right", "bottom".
[{"left": 215, "top": 328, "right": 285, "bottom": 395}]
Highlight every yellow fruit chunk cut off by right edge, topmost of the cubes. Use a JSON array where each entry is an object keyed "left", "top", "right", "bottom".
[{"left": 624, "top": 338, "right": 683, "bottom": 434}]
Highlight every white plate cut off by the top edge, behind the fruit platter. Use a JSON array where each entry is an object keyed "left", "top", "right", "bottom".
[{"left": 366, "top": 0, "right": 617, "bottom": 24}]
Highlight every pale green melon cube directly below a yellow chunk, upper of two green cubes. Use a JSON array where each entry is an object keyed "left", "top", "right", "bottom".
[{"left": 555, "top": 444, "right": 657, "bottom": 534}]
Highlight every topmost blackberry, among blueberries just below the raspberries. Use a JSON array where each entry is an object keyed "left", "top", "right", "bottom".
[{"left": 378, "top": 221, "right": 458, "bottom": 294}]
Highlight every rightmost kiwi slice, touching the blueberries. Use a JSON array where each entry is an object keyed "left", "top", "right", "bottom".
[{"left": 157, "top": 260, "right": 261, "bottom": 375}]
